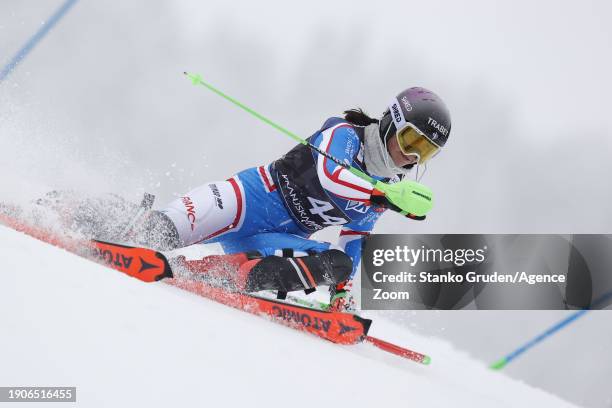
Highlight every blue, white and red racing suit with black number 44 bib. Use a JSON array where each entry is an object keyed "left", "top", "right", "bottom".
[{"left": 162, "top": 118, "right": 388, "bottom": 278}]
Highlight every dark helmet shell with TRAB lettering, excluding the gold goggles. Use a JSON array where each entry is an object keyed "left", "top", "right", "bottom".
[{"left": 380, "top": 87, "right": 451, "bottom": 161}]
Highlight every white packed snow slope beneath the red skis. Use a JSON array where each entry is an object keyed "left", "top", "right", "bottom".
[{"left": 0, "top": 226, "right": 572, "bottom": 408}]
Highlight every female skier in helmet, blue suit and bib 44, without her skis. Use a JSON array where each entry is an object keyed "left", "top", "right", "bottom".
[{"left": 133, "top": 88, "right": 451, "bottom": 310}]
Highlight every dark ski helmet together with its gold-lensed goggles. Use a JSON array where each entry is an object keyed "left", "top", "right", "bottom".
[{"left": 380, "top": 87, "right": 451, "bottom": 167}]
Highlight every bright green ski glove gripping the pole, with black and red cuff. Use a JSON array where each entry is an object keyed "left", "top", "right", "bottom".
[{"left": 370, "top": 180, "right": 433, "bottom": 220}]
